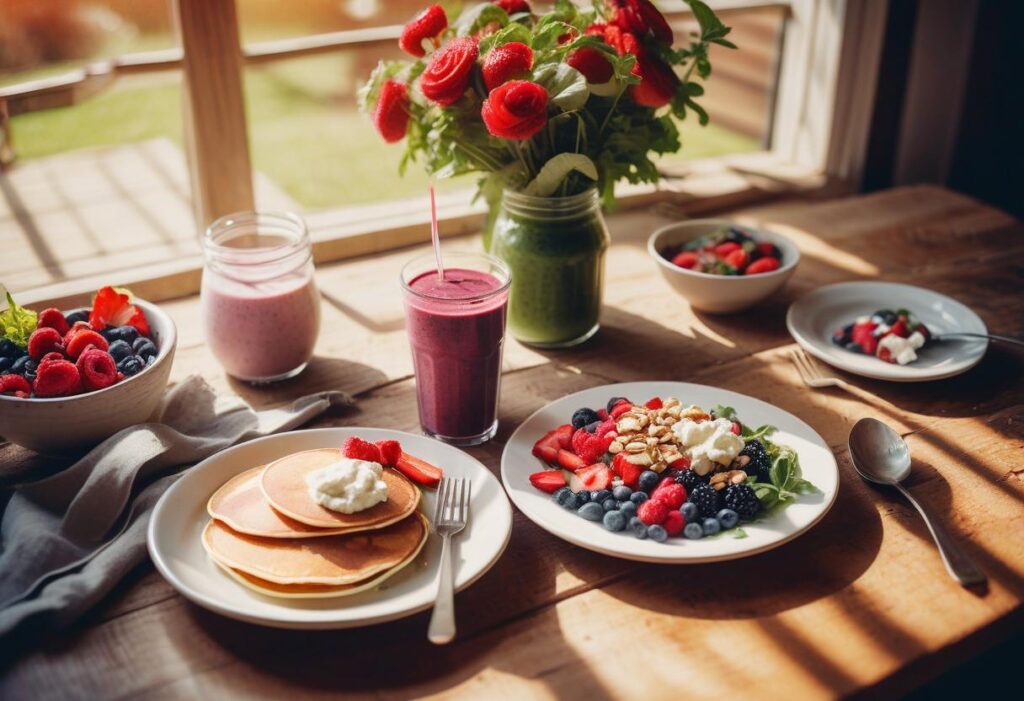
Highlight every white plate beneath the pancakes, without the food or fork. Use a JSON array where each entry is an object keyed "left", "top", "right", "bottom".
[{"left": 148, "top": 427, "right": 512, "bottom": 628}]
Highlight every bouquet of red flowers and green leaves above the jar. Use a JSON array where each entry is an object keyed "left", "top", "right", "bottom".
[{"left": 360, "top": 0, "right": 735, "bottom": 204}]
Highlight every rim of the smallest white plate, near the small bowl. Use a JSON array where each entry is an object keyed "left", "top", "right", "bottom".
[{"left": 785, "top": 280, "right": 988, "bottom": 383}]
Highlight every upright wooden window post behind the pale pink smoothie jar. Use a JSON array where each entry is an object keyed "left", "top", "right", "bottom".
[{"left": 170, "top": 0, "right": 255, "bottom": 232}]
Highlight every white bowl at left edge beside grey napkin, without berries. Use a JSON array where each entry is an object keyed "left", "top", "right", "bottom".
[{"left": 0, "top": 299, "right": 177, "bottom": 454}]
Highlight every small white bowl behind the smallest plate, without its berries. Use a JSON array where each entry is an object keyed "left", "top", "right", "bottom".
[{"left": 647, "top": 219, "right": 800, "bottom": 314}]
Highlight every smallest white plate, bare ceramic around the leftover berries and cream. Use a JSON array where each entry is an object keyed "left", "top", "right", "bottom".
[{"left": 785, "top": 282, "right": 988, "bottom": 382}]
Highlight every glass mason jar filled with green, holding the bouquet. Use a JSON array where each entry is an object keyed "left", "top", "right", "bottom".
[{"left": 490, "top": 188, "right": 608, "bottom": 348}]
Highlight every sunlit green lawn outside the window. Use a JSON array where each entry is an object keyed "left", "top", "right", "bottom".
[{"left": 11, "top": 55, "right": 759, "bottom": 209}]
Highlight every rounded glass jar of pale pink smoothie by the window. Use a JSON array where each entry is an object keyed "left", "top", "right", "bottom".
[{"left": 200, "top": 212, "right": 321, "bottom": 384}]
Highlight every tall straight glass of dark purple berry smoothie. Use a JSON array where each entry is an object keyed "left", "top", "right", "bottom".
[{"left": 401, "top": 253, "right": 510, "bottom": 445}]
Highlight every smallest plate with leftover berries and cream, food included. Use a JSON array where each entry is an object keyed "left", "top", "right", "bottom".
[{"left": 785, "top": 282, "right": 988, "bottom": 382}]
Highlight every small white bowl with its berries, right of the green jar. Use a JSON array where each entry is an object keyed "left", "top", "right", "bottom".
[{"left": 647, "top": 219, "right": 800, "bottom": 314}]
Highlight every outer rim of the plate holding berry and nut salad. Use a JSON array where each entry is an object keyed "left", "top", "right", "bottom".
[{"left": 501, "top": 380, "right": 842, "bottom": 565}]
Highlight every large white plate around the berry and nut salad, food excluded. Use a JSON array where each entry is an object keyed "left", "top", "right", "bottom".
[{"left": 502, "top": 382, "right": 839, "bottom": 564}]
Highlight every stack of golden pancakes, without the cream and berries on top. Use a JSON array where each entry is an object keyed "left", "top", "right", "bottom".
[{"left": 203, "top": 448, "right": 427, "bottom": 598}]
